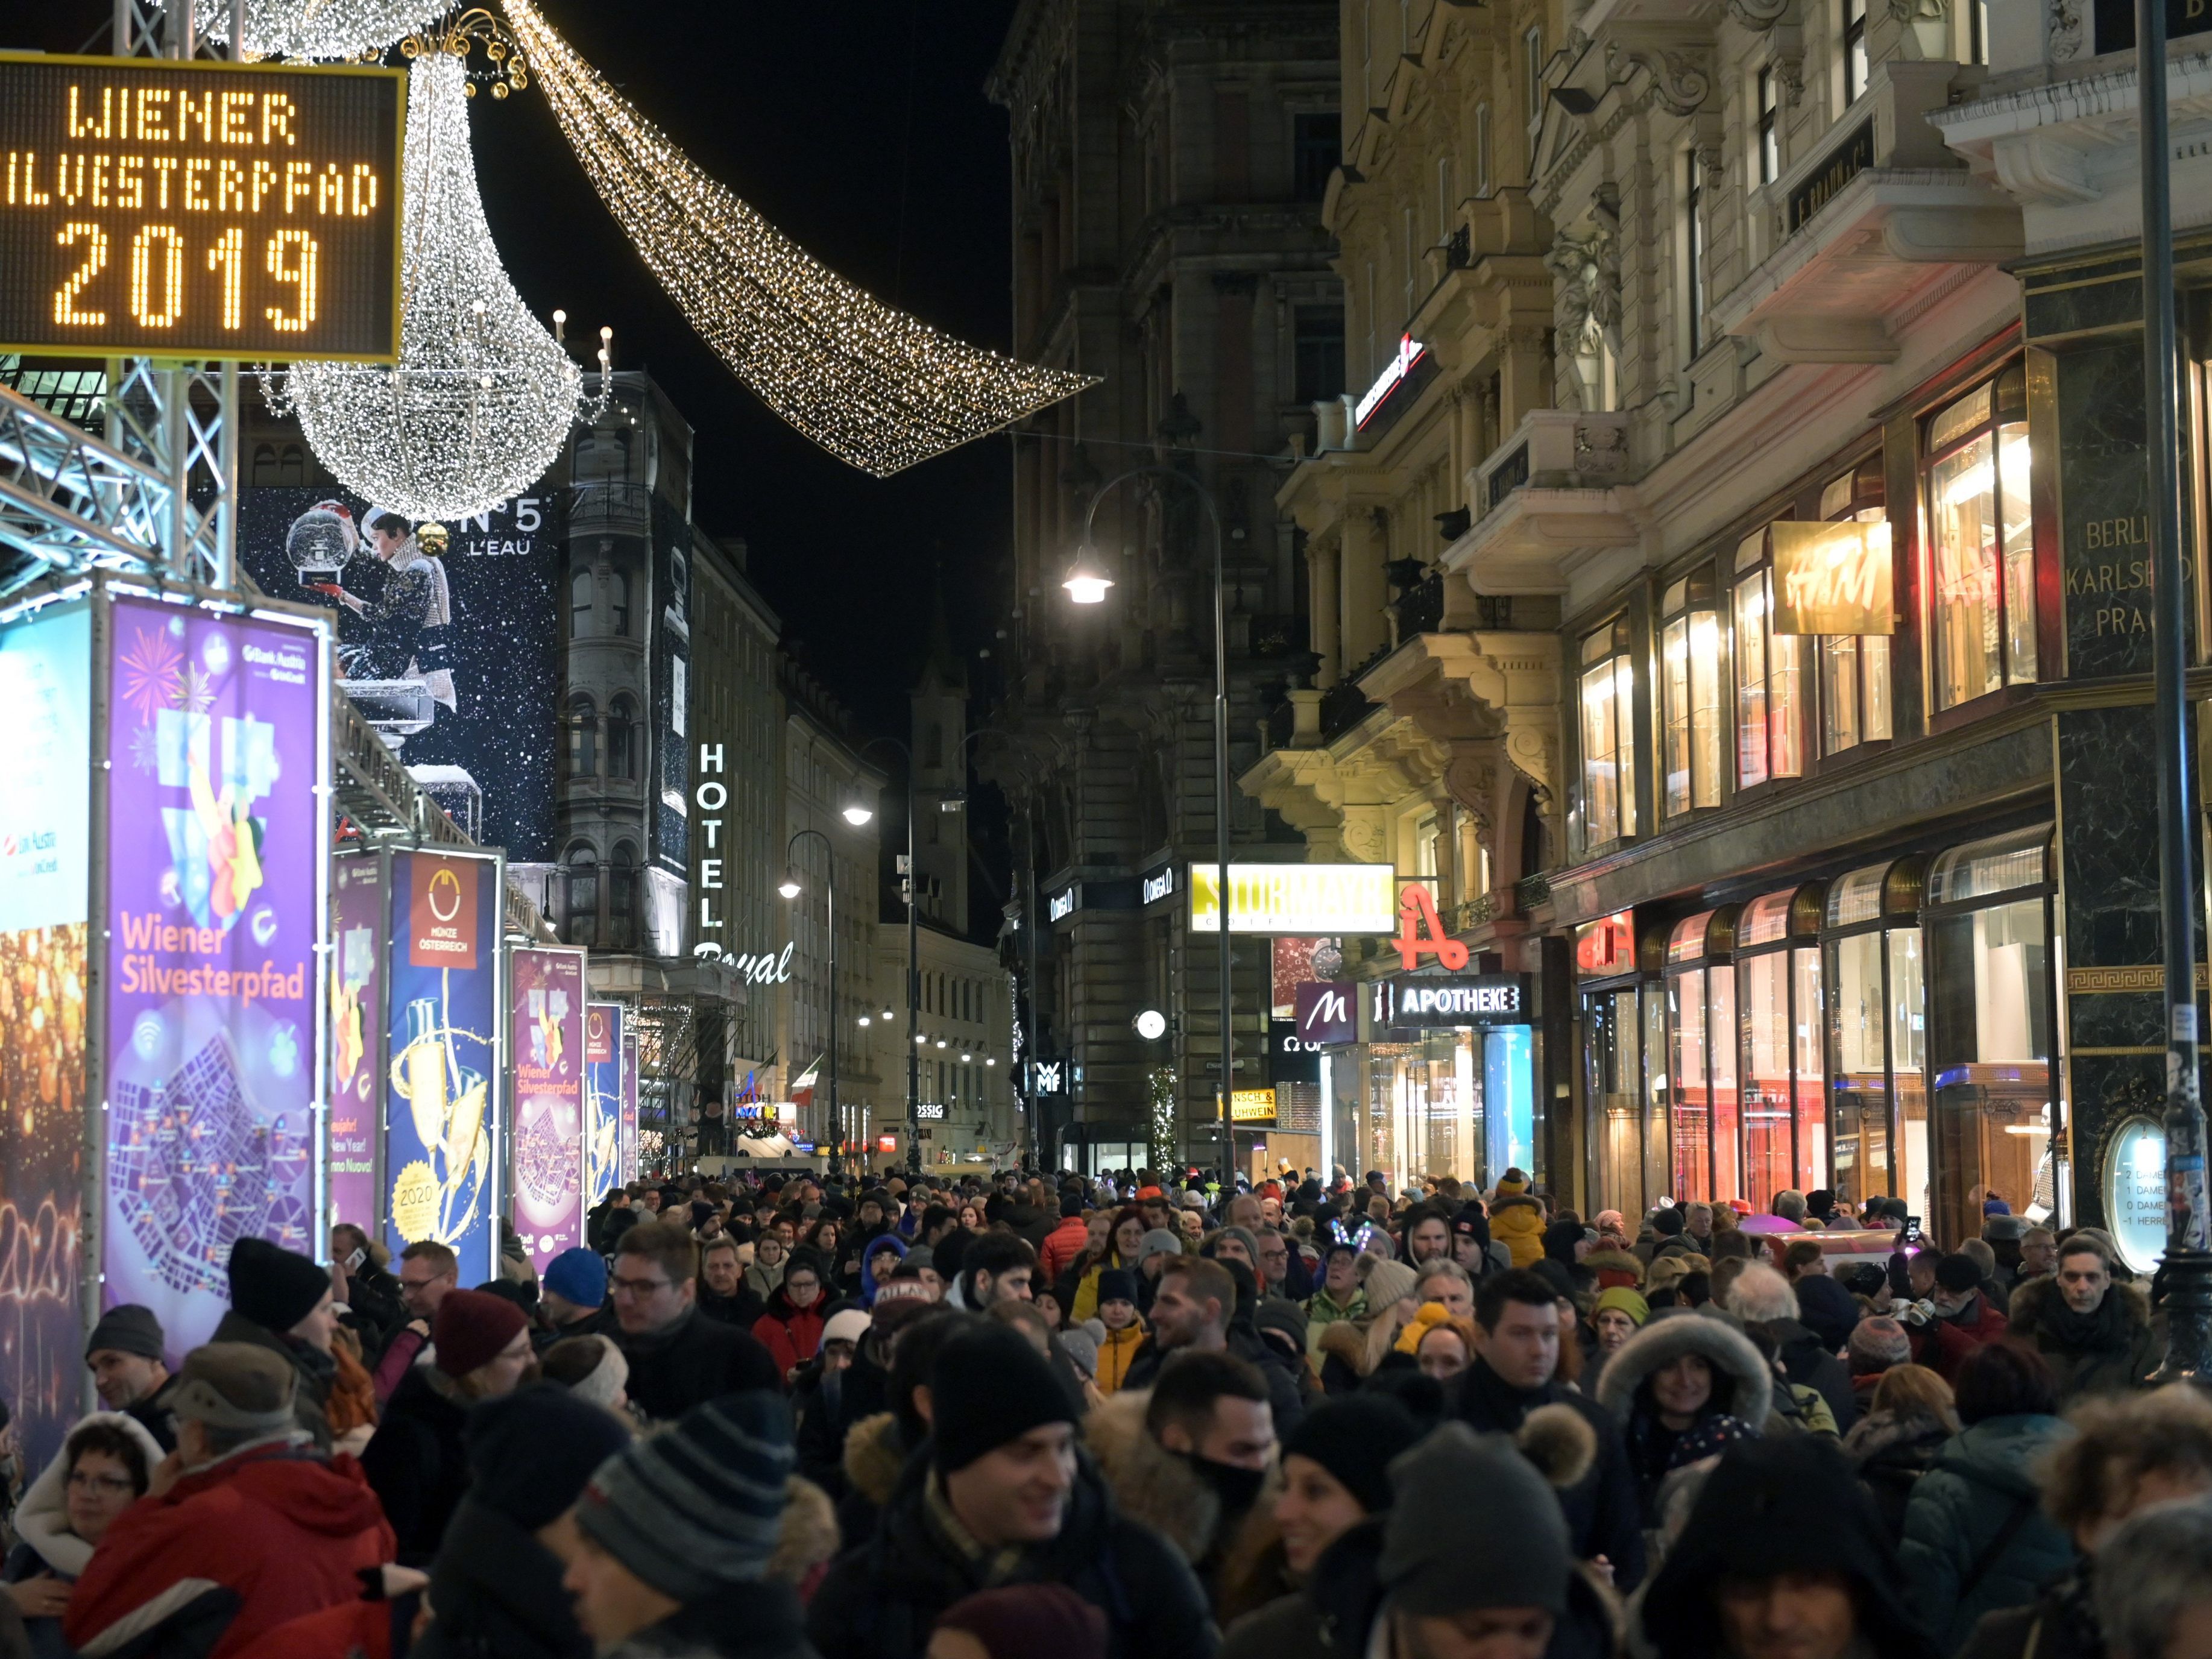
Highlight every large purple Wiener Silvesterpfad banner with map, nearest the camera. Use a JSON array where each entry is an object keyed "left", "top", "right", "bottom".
[{"left": 99, "top": 599, "right": 330, "bottom": 1365}]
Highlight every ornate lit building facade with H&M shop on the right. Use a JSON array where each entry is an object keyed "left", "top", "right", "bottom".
[{"left": 1241, "top": 0, "right": 2208, "bottom": 1239}]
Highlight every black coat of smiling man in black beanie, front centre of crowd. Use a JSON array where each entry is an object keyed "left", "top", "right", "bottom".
[{"left": 807, "top": 1447, "right": 1217, "bottom": 1659}]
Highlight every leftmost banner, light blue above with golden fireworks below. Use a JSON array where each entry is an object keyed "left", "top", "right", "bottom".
[{"left": 0, "top": 604, "right": 93, "bottom": 1469}]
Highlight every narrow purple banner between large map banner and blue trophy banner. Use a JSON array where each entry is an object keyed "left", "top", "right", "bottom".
[{"left": 330, "top": 854, "right": 385, "bottom": 1239}]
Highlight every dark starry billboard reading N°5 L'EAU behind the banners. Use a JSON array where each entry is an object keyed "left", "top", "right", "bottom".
[{"left": 239, "top": 486, "right": 564, "bottom": 860}]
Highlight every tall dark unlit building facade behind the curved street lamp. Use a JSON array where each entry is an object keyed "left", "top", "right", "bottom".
[{"left": 978, "top": 0, "right": 1343, "bottom": 1161}]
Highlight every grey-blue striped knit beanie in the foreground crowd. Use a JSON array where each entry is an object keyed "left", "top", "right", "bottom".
[{"left": 575, "top": 1389, "right": 796, "bottom": 1604}]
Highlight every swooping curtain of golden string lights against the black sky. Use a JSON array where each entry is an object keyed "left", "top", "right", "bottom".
[{"left": 505, "top": 0, "right": 1095, "bottom": 478}]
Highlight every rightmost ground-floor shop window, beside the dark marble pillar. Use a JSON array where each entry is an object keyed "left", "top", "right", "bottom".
[{"left": 1924, "top": 825, "right": 2057, "bottom": 1241}]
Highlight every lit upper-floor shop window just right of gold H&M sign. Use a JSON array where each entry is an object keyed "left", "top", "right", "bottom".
[{"left": 1920, "top": 363, "right": 2037, "bottom": 710}]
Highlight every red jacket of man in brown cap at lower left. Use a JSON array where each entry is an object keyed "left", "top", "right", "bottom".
[{"left": 62, "top": 1444, "right": 398, "bottom": 1659}]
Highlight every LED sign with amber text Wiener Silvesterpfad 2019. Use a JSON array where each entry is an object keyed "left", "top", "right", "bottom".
[{"left": 0, "top": 53, "right": 407, "bottom": 363}]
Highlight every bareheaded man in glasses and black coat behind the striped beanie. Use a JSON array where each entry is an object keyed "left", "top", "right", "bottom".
[{"left": 608, "top": 1221, "right": 783, "bottom": 1422}]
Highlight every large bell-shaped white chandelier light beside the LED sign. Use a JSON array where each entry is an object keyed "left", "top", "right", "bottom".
[{"left": 270, "top": 46, "right": 613, "bottom": 520}]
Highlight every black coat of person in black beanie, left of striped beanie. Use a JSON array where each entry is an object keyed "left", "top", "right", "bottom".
[{"left": 409, "top": 1497, "right": 591, "bottom": 1659}]
